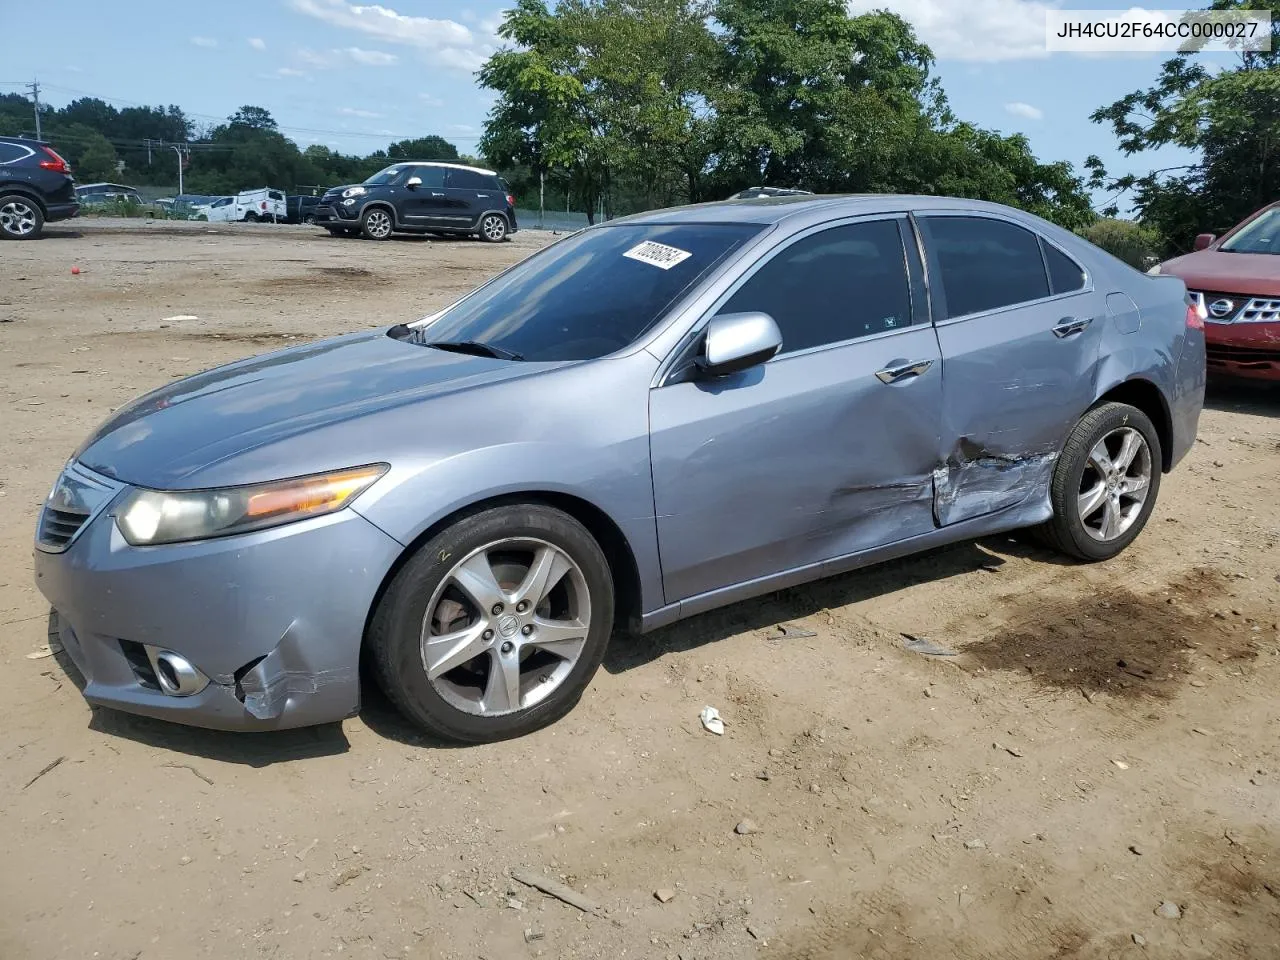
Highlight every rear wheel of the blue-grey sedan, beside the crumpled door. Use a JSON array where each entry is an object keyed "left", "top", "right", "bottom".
[{"left": 1037, "top": 403, "right": 1162, "bottom": 562}]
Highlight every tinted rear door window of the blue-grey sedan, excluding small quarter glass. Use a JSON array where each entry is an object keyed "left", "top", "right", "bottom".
[{"left": 922, "top": 216, "right": 1048, "bottom": 317}]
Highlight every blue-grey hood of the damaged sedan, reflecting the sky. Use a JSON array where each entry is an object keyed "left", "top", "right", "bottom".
[{"left": 76, "top": 330, "right": 562, "bottom": 489}]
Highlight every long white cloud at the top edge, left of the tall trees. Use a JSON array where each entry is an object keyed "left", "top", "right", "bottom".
[{"left": 289, "top": 0, "right": 493, "bottom": 70}]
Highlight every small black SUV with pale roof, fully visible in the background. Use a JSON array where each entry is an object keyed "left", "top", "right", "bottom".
[{"left": 314, "top": 160, "right": 516, "bottom": 243}]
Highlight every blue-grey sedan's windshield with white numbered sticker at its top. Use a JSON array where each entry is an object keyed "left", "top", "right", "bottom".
[{"left": 413, "top": 224, "right": 764, "bottom": 361}]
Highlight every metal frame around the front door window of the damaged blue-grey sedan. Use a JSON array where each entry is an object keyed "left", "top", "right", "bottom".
[{"left": 650, "top": 210, "right": 929, "bottom": 389}]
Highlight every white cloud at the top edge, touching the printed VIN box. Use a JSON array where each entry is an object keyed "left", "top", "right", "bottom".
[{"left": 847, "top": 0, "right": 1059, "bottom": 63}]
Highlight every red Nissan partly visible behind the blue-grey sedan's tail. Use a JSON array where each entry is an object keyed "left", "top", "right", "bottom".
[{"left": 1151, "top": 202, "right": 1280, "bottom": 380}]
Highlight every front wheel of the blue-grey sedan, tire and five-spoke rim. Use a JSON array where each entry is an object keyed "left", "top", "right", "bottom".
[{"left": 366, "top": 504, "right": 613, "bottom": 744}]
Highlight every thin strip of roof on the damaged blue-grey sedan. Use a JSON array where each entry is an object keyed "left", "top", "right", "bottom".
[{"left": 608, "top": 193, "right": 1054, "bottom": 225}]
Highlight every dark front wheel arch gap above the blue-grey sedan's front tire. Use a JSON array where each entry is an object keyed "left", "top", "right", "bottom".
[{"left": 361, "top": 490, "right": 641, "bottom": 650}]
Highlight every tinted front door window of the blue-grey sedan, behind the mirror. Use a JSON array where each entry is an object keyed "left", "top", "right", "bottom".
[{"left": 718, "top": 220, "right": 911, "bottom": 353}]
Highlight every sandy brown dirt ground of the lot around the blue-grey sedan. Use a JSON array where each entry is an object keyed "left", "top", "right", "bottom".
[{"left": 0, "top": 221, "right": 1280, "bottom": 960}]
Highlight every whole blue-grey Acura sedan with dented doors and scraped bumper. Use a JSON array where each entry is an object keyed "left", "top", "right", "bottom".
[{"left": 36, "top": 196, "right": 1204, "bottom": 742}]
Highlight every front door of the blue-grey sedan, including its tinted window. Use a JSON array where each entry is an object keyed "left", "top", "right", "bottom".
[{"left": 649, "top": 218, "right": 942, "bottom": 603}]
